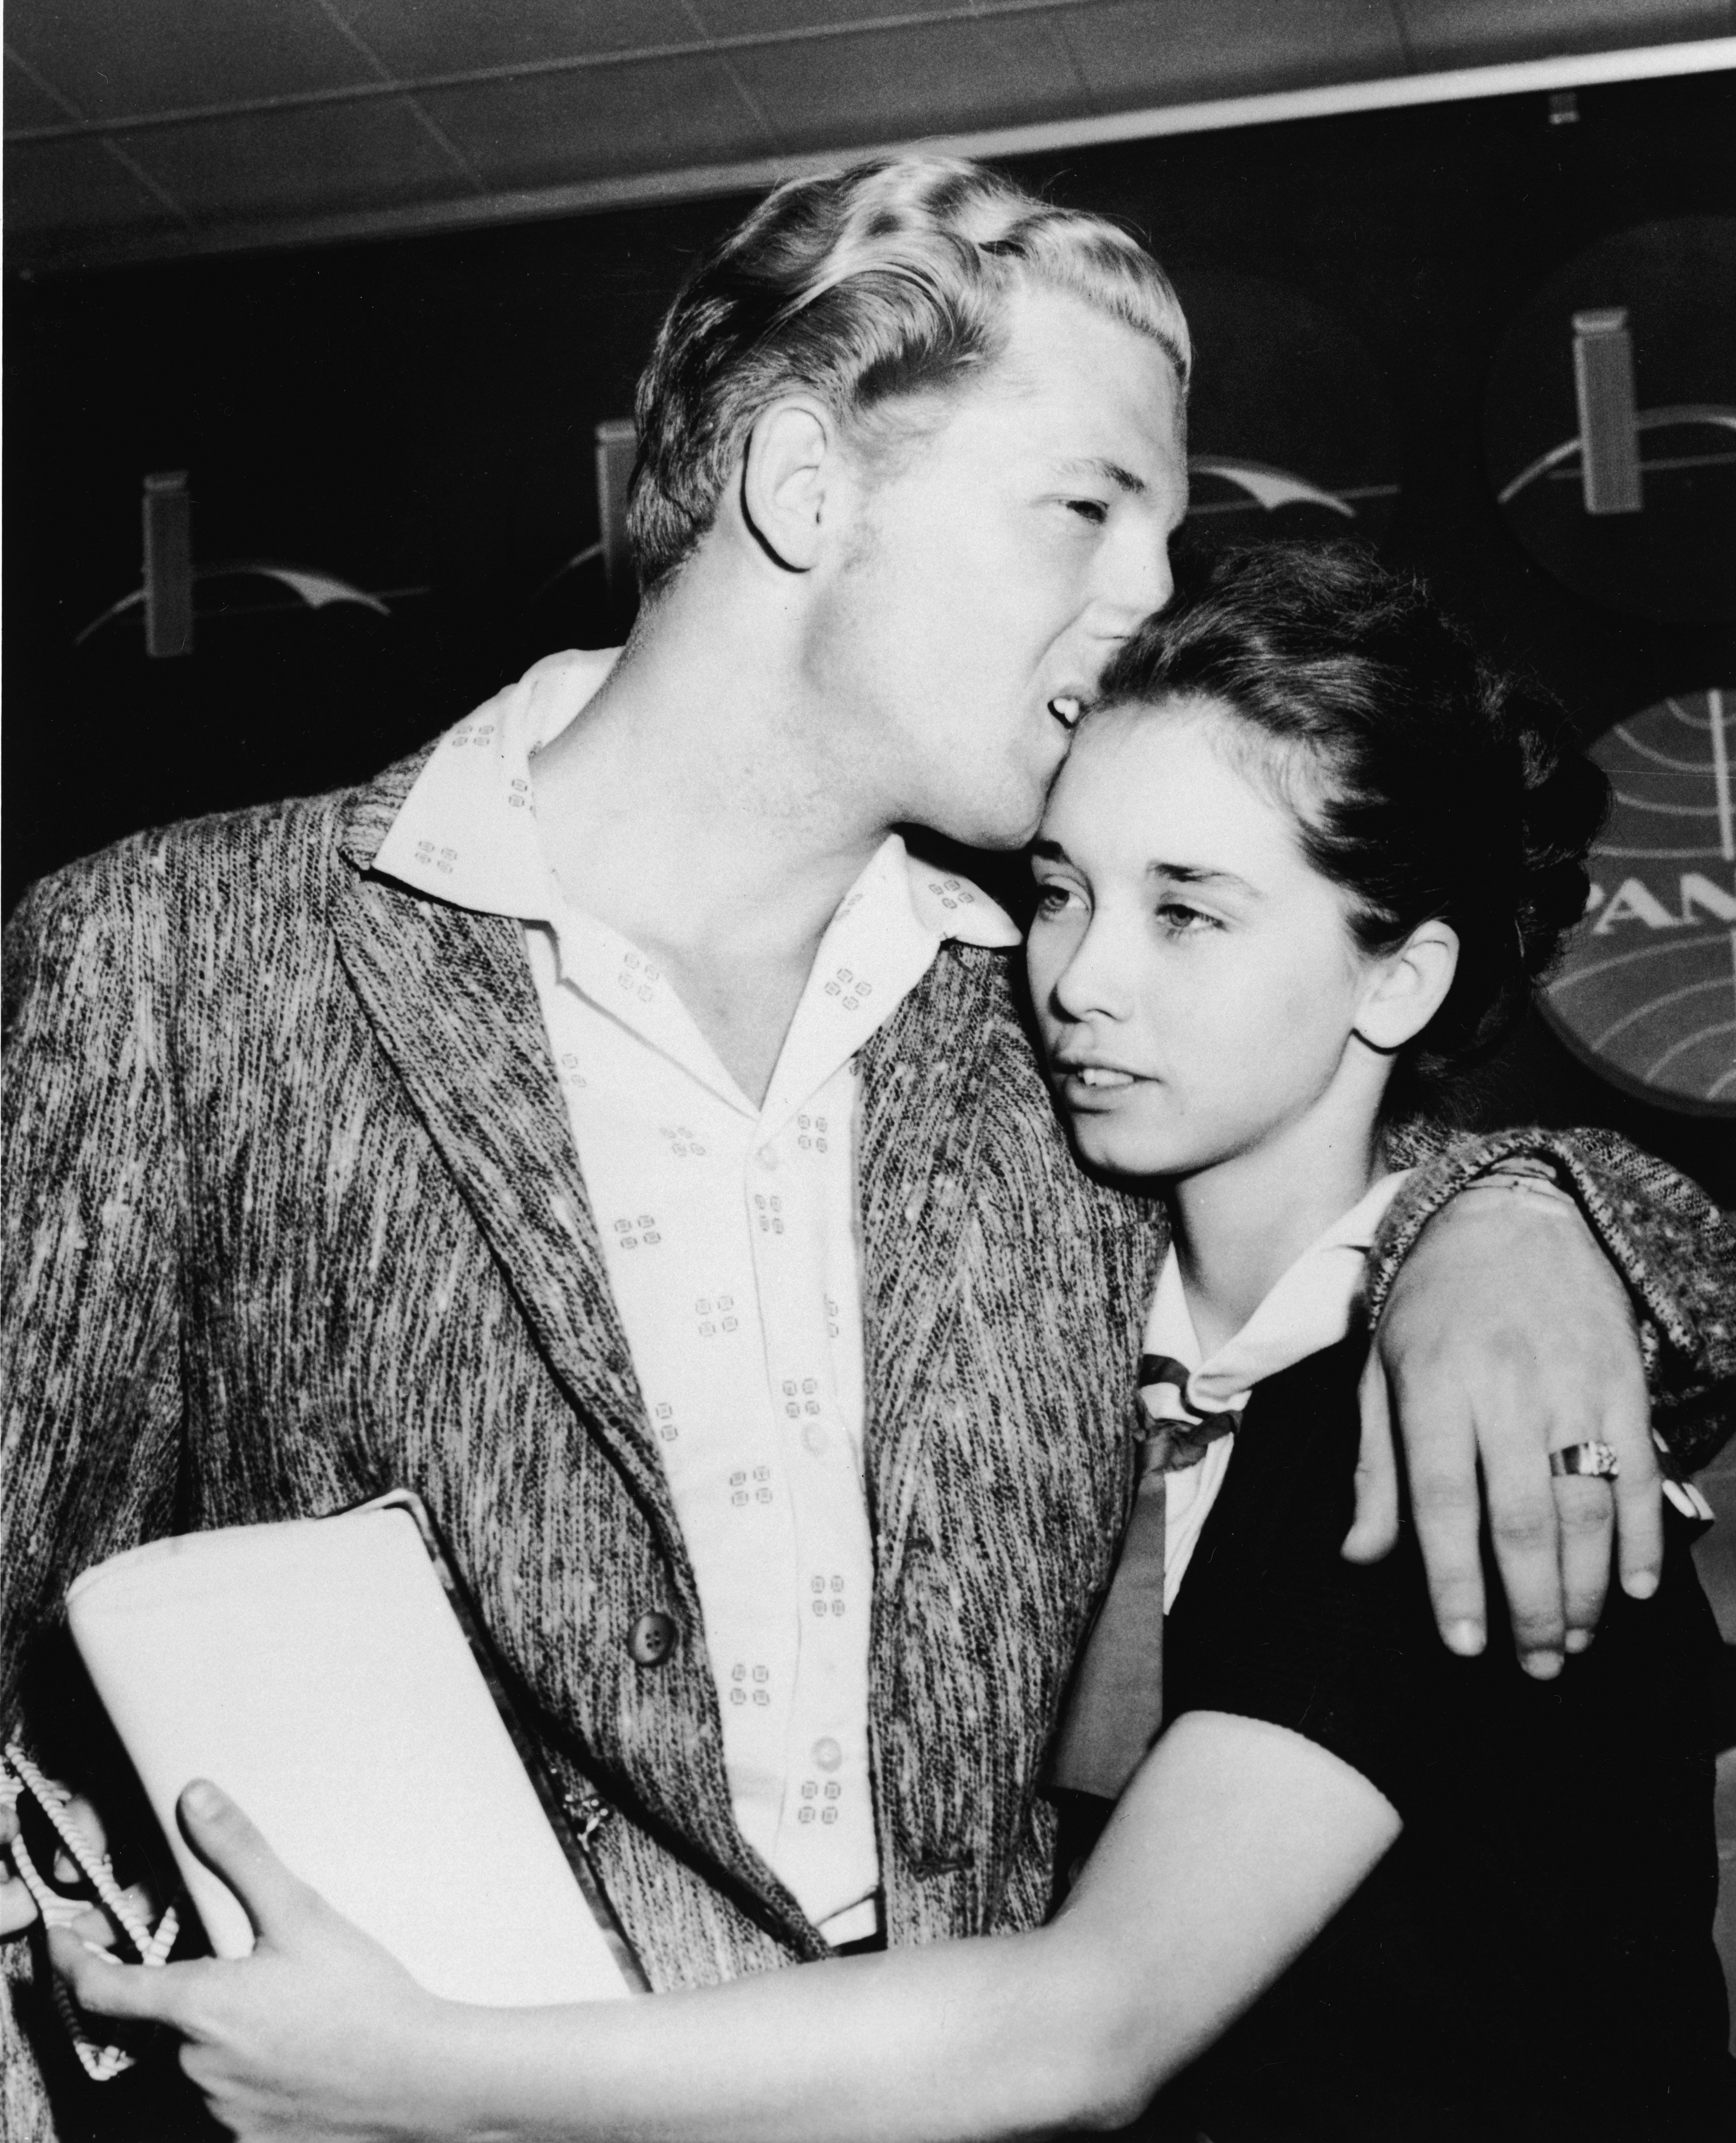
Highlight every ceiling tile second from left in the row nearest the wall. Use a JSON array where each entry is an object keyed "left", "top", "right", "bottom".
[{"left": 127, "top": 99, "right": 458, "bottom": 223}]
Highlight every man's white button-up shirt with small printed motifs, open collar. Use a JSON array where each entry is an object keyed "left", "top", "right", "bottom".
[{"left": 375, "top": 654, "right": 1018, "bottom": 1942}]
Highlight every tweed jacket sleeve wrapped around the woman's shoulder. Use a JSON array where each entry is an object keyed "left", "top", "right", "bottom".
[{"left": 1370, "top": 1127, "right": 1736, "bottom": 1472}]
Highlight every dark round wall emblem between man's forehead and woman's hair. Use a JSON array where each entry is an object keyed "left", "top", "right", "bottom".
[{"left": 1177, "top": 268, "right": 1399, "bottom": 548}]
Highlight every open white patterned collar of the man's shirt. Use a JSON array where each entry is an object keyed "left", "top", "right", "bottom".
[{"left": 373, "top": 647, "right": 1018, "bottom": 945}]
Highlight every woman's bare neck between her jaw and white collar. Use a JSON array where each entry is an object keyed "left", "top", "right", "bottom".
[{"left": 1170, "top": 1112, "right": 1380, "bottom": 1354}]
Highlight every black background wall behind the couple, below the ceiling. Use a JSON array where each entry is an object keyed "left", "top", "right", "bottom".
[{"left": 4, "top": 75, "right": 1736, "bottom": 1204}]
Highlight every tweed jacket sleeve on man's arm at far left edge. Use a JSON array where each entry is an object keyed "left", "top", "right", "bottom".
[{"left": 0, "top": 838, "right": 186, "bottom": 1729}]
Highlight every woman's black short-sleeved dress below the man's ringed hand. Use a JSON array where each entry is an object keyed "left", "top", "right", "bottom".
[{"left": 1105, "top": 1340, "right": 1736, "bottom": 2143}]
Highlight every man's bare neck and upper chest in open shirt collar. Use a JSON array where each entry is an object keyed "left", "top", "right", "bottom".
[{"left": 532, "top": 585, "right": 892, "bottom": 1101}]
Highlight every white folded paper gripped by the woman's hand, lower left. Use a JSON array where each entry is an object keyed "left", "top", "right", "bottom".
[{"left": 67, "top": 1506, "right": 632, "bottom": 2006}]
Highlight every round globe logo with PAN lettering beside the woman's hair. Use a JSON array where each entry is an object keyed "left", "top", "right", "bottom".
[{"left": 1543, "top": 690, "right": 1736, "bottom": 1119}]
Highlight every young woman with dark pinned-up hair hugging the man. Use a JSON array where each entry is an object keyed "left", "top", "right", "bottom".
[{"left": 60, "top": 551, "right": 1736, "bottom": 2143}]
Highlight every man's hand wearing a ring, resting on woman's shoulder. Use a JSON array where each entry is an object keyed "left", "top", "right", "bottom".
[{"left": 1344, "top": 1179, "right": 1663, "bottom": 1678}]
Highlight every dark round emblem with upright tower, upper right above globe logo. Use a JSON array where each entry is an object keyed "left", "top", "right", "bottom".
[{"left": 1483, "top": 217, "right": 1736, "bottom": 624}]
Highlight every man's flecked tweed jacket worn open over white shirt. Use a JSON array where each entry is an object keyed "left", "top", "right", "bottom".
[{"left": 4, "top": 754, "right": 1732, "bottom": 2126}]
